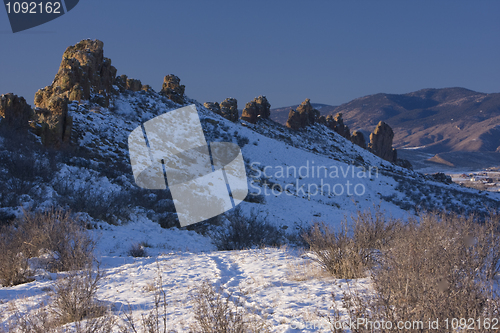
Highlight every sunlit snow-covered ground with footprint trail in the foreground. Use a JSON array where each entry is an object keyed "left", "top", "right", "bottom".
[{"left": 0, "top": 222, "right": 370, "bottom": 332}]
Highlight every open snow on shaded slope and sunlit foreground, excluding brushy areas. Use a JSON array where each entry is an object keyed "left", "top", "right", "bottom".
[{"left": 0, "top": 92, "right": 500, "bottom": 332}]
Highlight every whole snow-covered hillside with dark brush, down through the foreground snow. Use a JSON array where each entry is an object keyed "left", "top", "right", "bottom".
[{"left": 0, "top": 50, "right": 500, "bottom": 332}]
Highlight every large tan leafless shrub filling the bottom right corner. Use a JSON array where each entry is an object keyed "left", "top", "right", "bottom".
[{"left": 326, "top": 213, "right": 500, "bottom": 332}]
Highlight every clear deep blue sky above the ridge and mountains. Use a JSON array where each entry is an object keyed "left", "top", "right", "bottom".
[{"left": 0, "top": 0, "right": 500, "bottom": 108}]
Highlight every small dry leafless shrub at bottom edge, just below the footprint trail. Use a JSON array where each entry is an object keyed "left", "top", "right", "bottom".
[{"left": 192, "top": 281, "right": 269, "bottom": 333}]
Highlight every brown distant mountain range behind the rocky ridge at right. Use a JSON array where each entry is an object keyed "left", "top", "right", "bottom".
[{"left": 271, "top": 88, "right": 500, "bottom": 170}]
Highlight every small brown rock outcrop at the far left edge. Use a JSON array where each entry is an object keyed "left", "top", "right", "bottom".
[{"left": 0, "top": 93, "right": 33, "bottom": 129}]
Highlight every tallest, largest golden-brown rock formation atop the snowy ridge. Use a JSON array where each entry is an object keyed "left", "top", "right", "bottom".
[{"left": 35, "top": 39, "right": 116, "bottom": 109}]
